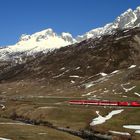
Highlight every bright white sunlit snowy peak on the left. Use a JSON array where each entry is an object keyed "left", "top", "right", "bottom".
[{"left": 0, "top": 28, "right": 76, "bottom": 60}]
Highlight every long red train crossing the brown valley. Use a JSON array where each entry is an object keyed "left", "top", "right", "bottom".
[{"left": 69, "top": 100, "right": 140, "bottom": 107}]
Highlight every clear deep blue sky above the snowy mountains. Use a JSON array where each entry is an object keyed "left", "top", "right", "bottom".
[{"left": 0, "top": 0, "right": 140, "bottom": 46}]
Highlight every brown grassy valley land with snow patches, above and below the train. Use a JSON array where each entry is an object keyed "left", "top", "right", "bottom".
[{"left": 0, "top": 66, "right": 140, "bottom": 140}]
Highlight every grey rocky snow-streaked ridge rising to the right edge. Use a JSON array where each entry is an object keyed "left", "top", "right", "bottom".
[{"left": 76, "top": 7, "right": 140, "bottom": 42}]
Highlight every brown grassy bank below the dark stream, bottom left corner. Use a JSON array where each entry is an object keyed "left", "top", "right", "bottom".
[{"left": 0, "top": 119, "right": 80, "bottom": 140}]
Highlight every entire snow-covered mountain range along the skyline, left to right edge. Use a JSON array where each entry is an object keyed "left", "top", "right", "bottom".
[{"left": 0, "top": 7, "right": 140, "bottom": 60}]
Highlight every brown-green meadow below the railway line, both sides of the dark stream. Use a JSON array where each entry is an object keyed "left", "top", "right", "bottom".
[{"left": 0, "top": 94, "right": 140, "bottom": 140}]
